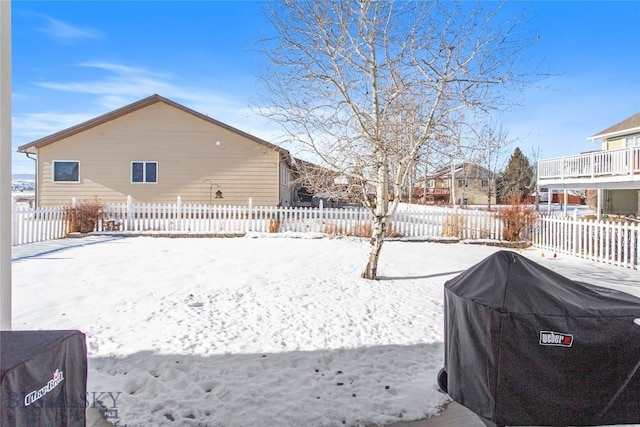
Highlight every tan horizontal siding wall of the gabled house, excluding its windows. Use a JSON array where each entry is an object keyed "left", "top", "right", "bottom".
[{"left": 38, "top": 103, "right": 280, "bottom": 206}]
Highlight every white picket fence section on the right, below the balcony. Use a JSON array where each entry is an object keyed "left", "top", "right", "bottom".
[{"left": 532, "top": 213, "right": 640, "bottom": 270}]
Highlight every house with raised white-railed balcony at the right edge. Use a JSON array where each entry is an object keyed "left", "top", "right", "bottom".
[{"left": 538, "top": 113, "right": 640, "bottom": 217}]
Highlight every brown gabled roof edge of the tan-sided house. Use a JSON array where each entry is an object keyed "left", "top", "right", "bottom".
[{"left": 18, "top": 94, "right": 293, "bottom": 165}]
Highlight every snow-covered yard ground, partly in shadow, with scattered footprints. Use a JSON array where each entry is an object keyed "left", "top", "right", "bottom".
[{"left": 13, "top": 235, "right": 640, "bottom": 426}]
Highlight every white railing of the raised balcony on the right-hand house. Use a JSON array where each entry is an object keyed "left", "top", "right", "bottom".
[{"left": 538, "top": 147, "right": 640, "bottom": 185}]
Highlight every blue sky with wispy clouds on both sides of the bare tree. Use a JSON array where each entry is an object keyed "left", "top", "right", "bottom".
[{"left": 12, "top": 0, "right": 640, "bottom": 174}]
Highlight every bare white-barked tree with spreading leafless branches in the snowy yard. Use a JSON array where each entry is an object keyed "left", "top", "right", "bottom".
[{"left": 261, "top": 0, "right": 534, "bottom": 279}]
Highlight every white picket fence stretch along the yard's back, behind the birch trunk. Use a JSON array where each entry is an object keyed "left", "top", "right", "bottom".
[{"left": 97, "top": 198, "right": 502, "bottom": 240}]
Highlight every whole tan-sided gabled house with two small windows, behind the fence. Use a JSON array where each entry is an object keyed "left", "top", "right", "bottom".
[{"left": 18, "top": 95, "right": 295, "bottom": 206}]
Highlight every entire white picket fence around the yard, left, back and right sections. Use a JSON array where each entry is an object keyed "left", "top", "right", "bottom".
[{"left": 12, "top": 198, "right": 640, "bottom": 269}]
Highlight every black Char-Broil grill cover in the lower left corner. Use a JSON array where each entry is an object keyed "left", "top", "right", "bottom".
[{"left": 0, "top": 330, "right": 87, "bottom": 427}]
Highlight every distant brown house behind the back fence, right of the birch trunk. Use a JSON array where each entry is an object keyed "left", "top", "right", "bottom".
[{"left": 413, "top": 163, "right": 498, "bottom": 205}]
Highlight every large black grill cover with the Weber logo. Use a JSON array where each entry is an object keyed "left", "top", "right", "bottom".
[{"left": 444, "top": 251, "right": 640, "bottom": 426}]
